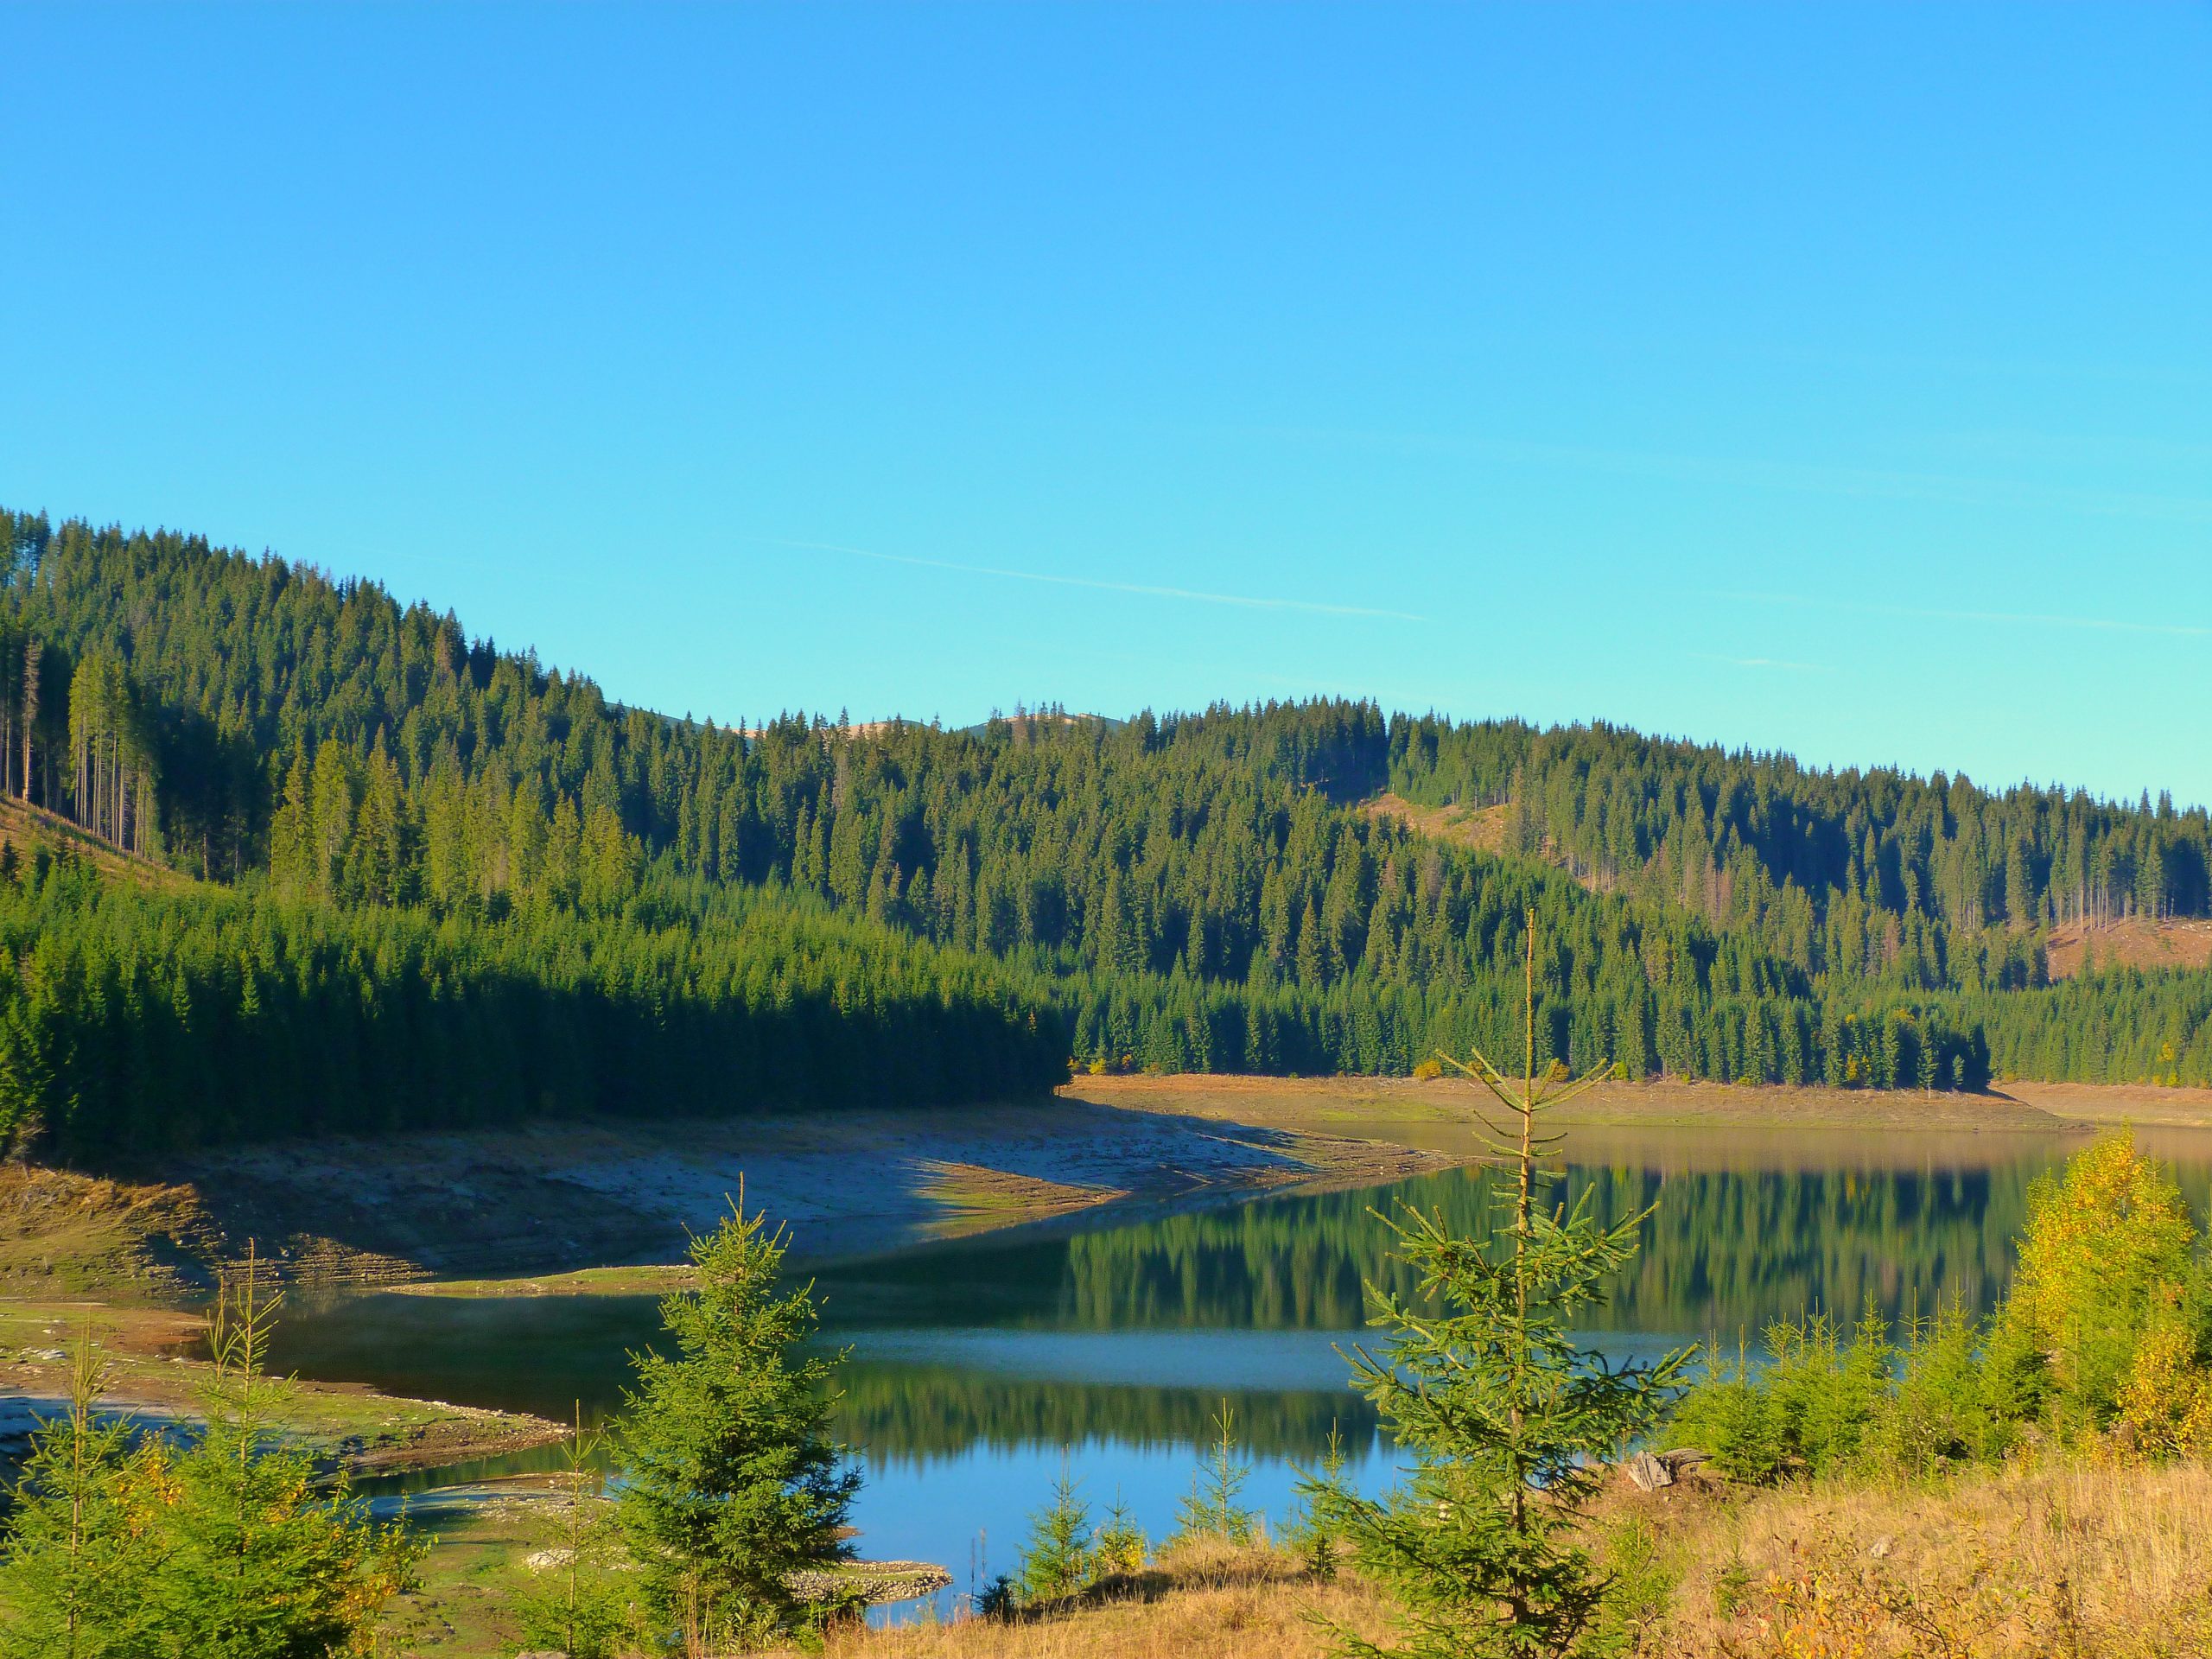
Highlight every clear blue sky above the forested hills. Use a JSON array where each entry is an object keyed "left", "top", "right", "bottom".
[{"left": 0, "top": 4, "right": 2212, "bottom": 801}]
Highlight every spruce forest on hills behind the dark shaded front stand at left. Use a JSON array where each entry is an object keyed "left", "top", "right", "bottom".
[{"left": 0, "top": 499, "right": 2212, "bottom": 1159}]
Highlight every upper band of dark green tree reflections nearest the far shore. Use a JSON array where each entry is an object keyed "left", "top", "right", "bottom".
[{"left": 1038, "top": 1157, "right": 2088, "bottom": 1334}]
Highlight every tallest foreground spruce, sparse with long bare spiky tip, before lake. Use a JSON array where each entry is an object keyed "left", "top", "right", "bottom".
[{"left": 1316, "top": 912, "right": 1690, "bottom": 1659}]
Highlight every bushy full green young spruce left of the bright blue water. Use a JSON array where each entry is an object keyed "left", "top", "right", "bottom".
[{"left": 617, "top": 1204, "right": 861, "bottom": 1646}]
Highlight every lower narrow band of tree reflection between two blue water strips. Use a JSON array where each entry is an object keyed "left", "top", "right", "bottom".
[{"left": 836, "top": 1360, "right": 1376, "bottom": 1462}]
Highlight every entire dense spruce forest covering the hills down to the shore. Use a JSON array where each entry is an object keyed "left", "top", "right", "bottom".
[{"left": 0, "top": 513, "right": 2212, "bottom": 1161}]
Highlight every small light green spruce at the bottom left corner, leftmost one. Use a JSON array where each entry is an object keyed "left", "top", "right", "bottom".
[{"left": 0, "top": 1330, "right": 150, "bottom": 1659}]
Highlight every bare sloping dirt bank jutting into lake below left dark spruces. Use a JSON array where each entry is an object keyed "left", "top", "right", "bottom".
[{"left": 0, "top": 1099, "right": 1438, "bottom": 1305}]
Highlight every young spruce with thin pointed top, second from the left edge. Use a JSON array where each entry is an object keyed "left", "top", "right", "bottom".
[{"left": 143, "top": 1256, "right": 423, "bottom": 1659}]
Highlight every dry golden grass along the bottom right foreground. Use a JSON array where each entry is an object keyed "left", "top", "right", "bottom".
[{"left": 787, "top": 1465, "right": 2212, "bottom": 1659}]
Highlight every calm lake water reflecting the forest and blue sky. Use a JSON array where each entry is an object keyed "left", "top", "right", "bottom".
[{"left": 274, "top": 1126, "right": 2212, "bottom": 1618}]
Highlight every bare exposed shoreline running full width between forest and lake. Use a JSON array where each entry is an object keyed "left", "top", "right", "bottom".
[{"left": 17, "top": 1075, "right": 2212, "bottom": 1327}]
